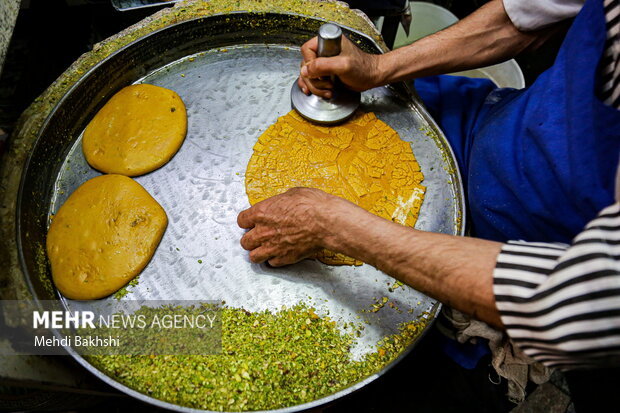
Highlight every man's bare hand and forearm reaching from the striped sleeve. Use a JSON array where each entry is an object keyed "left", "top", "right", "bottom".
[{"left": 238, "top": 188, "right": 502, "bottom": 327}]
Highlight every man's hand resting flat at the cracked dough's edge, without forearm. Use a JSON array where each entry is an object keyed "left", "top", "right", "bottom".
[{"left": 237, "top": 188, "right": 339, "bottom": 267}]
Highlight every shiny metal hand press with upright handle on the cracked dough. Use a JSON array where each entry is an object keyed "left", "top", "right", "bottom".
[{"left": 291, "top": 23, "right": 360, "bottom": 125}]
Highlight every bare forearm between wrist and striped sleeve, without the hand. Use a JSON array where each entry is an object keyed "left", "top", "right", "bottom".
[{"left": 323, "top": 203, "right": 502, "bottom": 328}]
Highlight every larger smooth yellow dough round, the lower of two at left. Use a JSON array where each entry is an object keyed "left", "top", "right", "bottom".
[{"left": 47, "top": 175, "right": 168, "bottom": 300}]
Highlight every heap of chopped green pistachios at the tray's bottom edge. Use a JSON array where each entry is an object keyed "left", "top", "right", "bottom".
[{"left": 87, "top": 304, "right": 426, "bottom": 411}]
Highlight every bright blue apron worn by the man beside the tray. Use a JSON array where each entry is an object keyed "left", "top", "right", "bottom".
[{"left": 415, "top": 0, "right": 620, "bottom": 367}]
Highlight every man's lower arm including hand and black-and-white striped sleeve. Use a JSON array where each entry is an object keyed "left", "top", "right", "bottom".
[{"left": 238, "top": 188, "right": 620, "bottom": 367}]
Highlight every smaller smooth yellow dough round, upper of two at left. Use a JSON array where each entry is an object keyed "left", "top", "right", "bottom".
[{"left": 82, "top": 84, "right": 187, "bottom": 176}]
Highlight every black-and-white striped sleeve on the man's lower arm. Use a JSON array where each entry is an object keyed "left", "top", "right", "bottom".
[{"left": 493, "top": 203, "right": 620, "bottom": 369}]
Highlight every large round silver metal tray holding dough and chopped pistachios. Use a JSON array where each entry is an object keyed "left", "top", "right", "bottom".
[{"left": 17, "top": 9, "right": 464, "bottom": 412}]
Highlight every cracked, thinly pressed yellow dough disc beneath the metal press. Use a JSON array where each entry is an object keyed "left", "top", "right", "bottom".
[{"left": 245, "top": 111, "right": 426, "bottom": 265}]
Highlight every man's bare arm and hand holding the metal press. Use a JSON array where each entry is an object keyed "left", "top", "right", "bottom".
[{"left": 299, "top": 0, "right": 555, "bottom": 97}]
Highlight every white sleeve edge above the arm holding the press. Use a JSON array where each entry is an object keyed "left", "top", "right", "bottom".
[{"left": 503, "top": 0, "right": 585, "bottom": 31}]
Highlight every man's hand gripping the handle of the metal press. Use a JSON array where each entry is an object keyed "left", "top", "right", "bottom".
[{"left": 297, "top": 36, "right": 381, "bottom": 99}]
